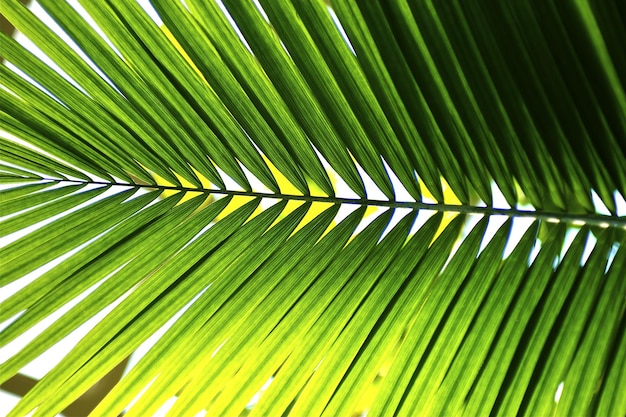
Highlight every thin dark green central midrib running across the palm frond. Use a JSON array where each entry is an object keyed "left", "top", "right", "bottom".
[{"left": 12, "top": 177, "right": 626, "bottom": 229}]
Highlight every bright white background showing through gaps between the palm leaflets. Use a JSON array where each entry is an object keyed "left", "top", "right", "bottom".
[{"left": 0, "top": 0, "right": 626, "bottom": 416}]
